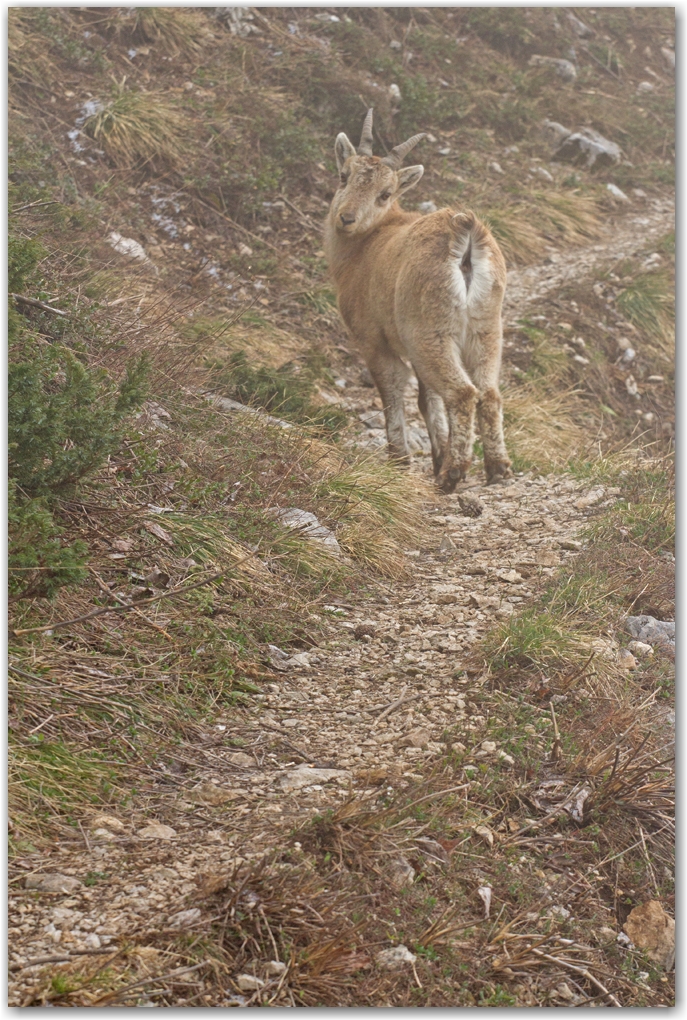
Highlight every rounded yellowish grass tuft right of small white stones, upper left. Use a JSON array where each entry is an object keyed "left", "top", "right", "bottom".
[{"left": 84, "top": 87, "right": 184, "bottom": 166}]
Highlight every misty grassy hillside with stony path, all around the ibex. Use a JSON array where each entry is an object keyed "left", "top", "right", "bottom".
[{"left": 8, "top": 6, "right": 675, "bottom": 1007}]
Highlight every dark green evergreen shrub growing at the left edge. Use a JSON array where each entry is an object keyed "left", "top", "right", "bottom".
[{"left": 7, "top": 230, "right": 148, "bottom": 599}]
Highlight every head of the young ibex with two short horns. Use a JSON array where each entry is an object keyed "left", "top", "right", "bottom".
[{"left": 330, "top": 110, "right": 425, "bottom": 234}]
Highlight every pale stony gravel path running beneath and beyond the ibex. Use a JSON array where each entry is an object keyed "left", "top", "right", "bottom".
[{"left": 8, "top": 203, "right": 672, "bottom": 1005}]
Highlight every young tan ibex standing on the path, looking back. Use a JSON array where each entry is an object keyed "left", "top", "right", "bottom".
[{"left": 324, "top": 110, "right": 513, "bottom": 493}]
